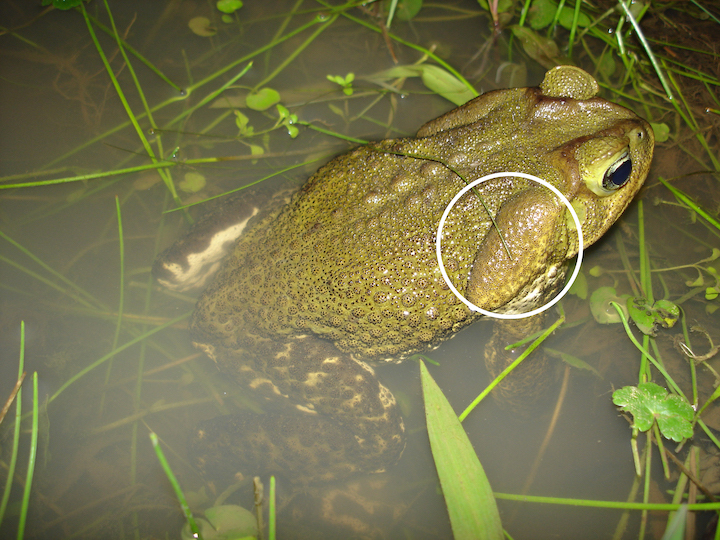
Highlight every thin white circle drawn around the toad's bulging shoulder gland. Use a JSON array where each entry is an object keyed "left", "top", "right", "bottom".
[{"left": 435, "top": 172, "right": 584, "bottom": 319}]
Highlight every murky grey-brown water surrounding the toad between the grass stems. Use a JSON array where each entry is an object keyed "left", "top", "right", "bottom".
[{"left": 0, "top": 1, "right": 720, "bottom": 539}]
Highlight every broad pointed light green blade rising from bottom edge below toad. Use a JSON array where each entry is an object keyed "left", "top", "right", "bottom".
[{"left": 420, "top": 360, "right": 504, "bottom": 540}]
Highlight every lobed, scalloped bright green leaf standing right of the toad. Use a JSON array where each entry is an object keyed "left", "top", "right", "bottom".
[{"left": 613, "top": 382, "right": 694, "bottom": 442}]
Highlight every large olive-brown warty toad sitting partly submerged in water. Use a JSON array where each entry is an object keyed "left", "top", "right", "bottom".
[{"left": 191, "top": 67, "right": 653, "bottom": 479}]
